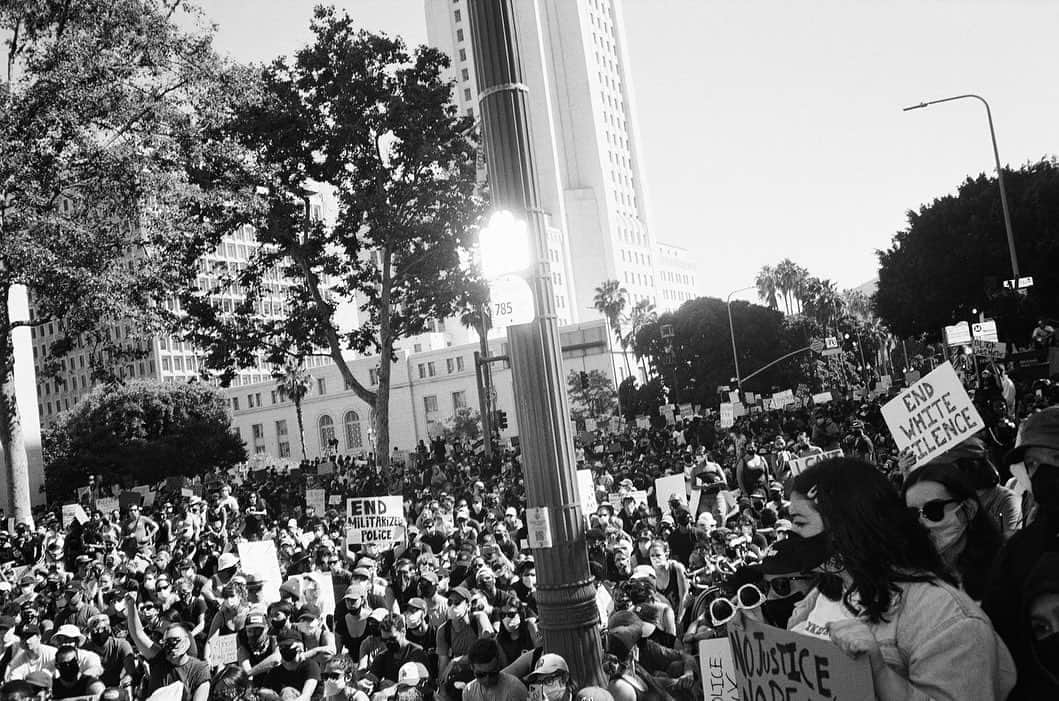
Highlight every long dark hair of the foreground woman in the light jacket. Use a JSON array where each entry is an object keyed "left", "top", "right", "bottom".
[{"left": 791, "top": 457, "right": 955, "bottom": 623}]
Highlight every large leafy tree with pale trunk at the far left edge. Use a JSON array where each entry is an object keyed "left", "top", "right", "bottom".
[{"left": 0, "top": 0, "right": 230, "bottom": 522}]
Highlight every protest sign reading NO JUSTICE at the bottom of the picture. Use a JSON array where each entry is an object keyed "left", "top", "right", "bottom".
[{"left": 722, "top": 611, "right": 875, "bottom": 701}]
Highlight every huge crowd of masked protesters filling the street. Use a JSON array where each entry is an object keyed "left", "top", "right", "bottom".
[{"left": 0, "top": 364, "right": 1059, "bottom": 701}]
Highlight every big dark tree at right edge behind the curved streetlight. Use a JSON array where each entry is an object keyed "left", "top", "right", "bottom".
[{"left": 874, "top": 158, "right": 1059, "bottom": 343}]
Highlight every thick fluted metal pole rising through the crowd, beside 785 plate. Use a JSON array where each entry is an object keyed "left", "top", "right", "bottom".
[{"left": 468, "top": 0, "right": 606, "bottom": 686}]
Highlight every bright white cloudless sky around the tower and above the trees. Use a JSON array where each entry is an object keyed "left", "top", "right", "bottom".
[{"left": 196, "top": 0, "right": 1059, "bottom": 298}]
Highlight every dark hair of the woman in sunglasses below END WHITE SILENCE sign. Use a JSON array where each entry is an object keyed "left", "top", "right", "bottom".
[{"left": 904, "top": 463, "right": 1004, "bottom": 600}]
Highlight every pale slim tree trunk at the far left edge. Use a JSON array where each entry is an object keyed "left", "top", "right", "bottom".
[{"left": 0, "top": 286, "right": 33, "bottom": 526}]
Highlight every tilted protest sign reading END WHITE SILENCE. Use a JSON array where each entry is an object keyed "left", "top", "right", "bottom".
[{"left": 882, "top": 362, "right": 985, "bottom": 469}]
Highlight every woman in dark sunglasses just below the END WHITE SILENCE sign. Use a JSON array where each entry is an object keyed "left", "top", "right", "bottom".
[{"left": 904, "top": 463, "right": 1003, "bottom": 601}]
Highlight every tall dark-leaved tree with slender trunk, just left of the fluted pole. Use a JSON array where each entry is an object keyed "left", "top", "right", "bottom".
[{"left": 183, "top": 7, "right": 482, "bottom": 470}]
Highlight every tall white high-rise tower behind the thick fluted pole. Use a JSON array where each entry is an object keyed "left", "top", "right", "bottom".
[{"left": 425, "top": 0, "right": 661, "bottom": 349}]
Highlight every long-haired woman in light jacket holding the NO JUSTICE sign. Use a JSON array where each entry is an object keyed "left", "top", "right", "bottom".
[{"left": 788, "top": 459, "right": 1015, "bottom": 701}]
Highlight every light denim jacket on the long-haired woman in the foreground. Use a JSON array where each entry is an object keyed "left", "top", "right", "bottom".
[{"left": 788, "top": 581, "right": 1016, "bottom": 701}]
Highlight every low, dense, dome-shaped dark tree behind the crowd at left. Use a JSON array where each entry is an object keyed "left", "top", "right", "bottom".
[{"left": 44, "top": 381, "right": 247, "bottom": 500}]
